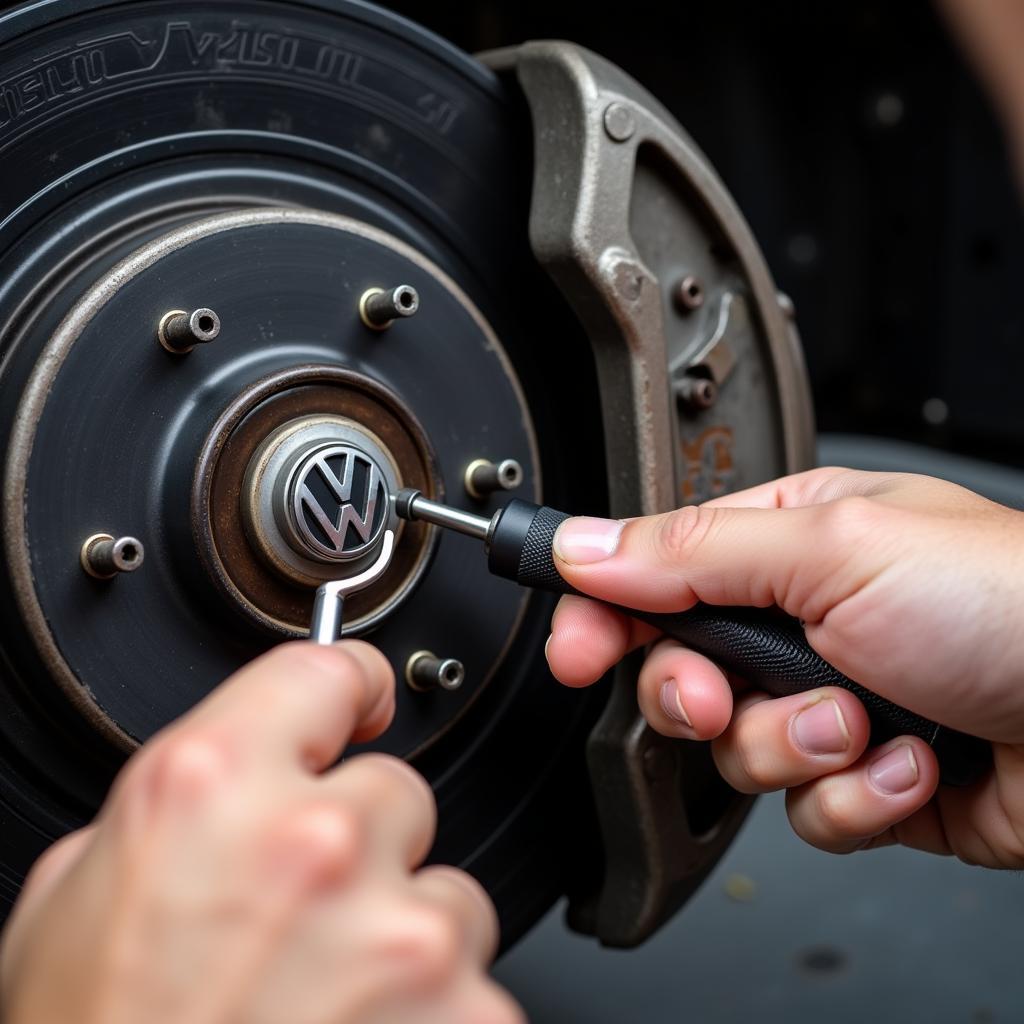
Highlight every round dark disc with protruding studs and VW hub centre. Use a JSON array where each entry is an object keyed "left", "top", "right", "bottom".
[{"left": 8, "top": 209, "right": 538, "bottom": 753}]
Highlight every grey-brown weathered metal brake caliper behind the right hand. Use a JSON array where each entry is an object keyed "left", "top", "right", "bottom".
[{"left": 483, "top": 41, "right": 813, "bottom": 946}]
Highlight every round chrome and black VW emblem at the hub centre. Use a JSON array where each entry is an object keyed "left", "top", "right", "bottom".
[{"left": 289, "top": 444, "right": 388, "bottom": 562}]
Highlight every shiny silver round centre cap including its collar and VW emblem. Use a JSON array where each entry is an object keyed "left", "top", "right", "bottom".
[{"left": 241, "top": 416, "right": 402, "bottom": 585}]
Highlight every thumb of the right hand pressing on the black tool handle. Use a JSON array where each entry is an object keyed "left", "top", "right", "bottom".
[{"left": 554, "top": 498, "right": 881, "bottom": 623}]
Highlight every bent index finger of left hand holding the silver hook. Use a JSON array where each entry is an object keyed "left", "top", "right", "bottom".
[{"left": 173, "top": 640, "right": 394, "bottom": 771}]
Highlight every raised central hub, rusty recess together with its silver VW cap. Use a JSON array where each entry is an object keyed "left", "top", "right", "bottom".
[{"left": 190, "top": 365, "right": 443, "bottom": 637}]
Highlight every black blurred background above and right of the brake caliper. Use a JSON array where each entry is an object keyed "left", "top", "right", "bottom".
[{"left": 387, "top": 0, "right": 1024, "bottom": 466}]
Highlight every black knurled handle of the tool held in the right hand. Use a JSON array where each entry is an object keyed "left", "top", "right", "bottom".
[{"left": 492, "top": 502, "right": 991, "bottom": 785}]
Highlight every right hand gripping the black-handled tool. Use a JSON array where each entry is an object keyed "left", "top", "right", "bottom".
[{"left": 548, "top": 469, "right": 1024, "bottom": 868}]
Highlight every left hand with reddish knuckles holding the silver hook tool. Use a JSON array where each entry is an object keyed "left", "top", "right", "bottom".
[{"left": 0, "top": 642, "right": 522, "bottom": 1024}]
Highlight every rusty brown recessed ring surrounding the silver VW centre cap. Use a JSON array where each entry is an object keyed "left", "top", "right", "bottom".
[{"left": 191, "top": 366, "right": 442, "bottom": 636}]
